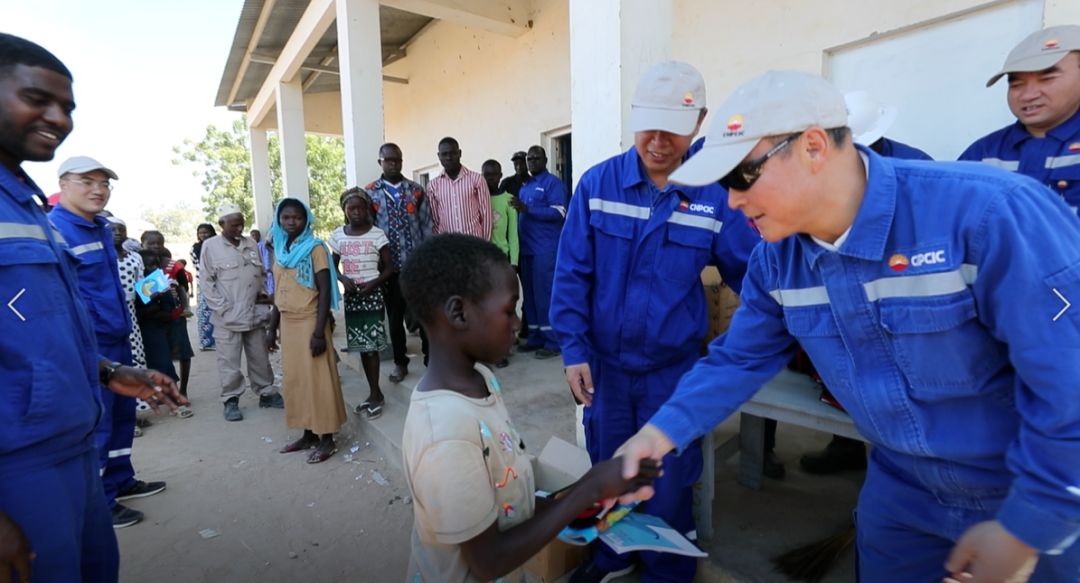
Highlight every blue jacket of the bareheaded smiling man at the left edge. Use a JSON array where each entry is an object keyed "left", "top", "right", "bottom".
[{"left": 0, "top": 166, "right": 102, "bottom": 477}]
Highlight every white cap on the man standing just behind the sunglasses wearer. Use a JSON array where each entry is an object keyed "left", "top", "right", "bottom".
[{"left": 630, "top": 60, "right": 705, "bottom": 136}]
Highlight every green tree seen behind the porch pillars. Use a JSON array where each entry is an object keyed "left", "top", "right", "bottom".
[{"left": 173, "top": 118, "right": 345, "bottom": 236}]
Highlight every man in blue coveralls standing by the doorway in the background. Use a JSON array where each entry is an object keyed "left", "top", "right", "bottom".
[{"left": 514, "top": 146, "right": 570, "bottom": 360}]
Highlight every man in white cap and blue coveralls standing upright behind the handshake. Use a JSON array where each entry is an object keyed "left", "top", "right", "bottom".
[{"left": 551, "top": 62, "right": 760, "bottom": 583}]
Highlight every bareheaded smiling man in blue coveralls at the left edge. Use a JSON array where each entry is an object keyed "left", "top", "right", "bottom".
[{"left": 0, "top": 33, "right": 187, "bottom": 583}]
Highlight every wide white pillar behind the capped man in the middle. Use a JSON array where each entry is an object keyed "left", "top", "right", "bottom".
[{"left": 570, "top": 0, "right": 673, "bottom": 184}]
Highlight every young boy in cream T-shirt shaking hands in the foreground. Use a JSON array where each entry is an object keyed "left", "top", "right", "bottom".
[{"left": 401, "top": 233, "right": 659, "bottom": 583}]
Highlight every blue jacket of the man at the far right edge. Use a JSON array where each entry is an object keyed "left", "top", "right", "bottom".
[{"left": 960, "top": 107, "right": 1080, "bottom": 217}]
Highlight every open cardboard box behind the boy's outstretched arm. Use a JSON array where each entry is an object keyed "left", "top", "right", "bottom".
[{"left": 525, "top": 437, "right": 592, "bottom": 583}]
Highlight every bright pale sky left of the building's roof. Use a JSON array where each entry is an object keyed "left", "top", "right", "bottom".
[{"left": 6, "top": 0, "right": 243, "bottom": 221}]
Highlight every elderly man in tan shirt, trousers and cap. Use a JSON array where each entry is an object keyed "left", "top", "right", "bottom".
[{"left": 199, "top": 204, "right": 285, "bottom": 421}]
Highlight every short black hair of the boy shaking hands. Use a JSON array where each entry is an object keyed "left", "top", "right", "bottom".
[{"left": 401, "top": 233, "right": 510, "bottom": 324}]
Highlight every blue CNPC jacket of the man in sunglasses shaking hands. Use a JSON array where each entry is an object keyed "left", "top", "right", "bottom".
[{"left": 651, "top": 148, "right": 1080, "bottom": 552}]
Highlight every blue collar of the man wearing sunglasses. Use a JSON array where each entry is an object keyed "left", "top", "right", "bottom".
[{"left": 798, "top": 145, "right": 896, "bottom": 266}]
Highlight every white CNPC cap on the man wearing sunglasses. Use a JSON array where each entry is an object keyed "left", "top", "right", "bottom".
[{"left": 671, "top": 71, "right": 848, "bottom": 185}]
